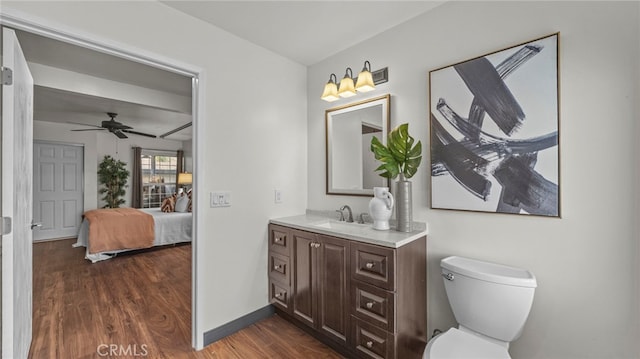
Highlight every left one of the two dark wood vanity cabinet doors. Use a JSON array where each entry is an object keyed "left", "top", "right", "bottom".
[{"left": 292, "top": 230, "right": 318, "bottom": 328}]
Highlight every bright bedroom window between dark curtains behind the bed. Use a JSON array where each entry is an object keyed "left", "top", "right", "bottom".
[{"left": 141, "top": 150, "right": 178, "bottom": 208}]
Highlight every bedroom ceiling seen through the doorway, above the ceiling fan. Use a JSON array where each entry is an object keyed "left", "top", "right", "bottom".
[{"left": 16, "top": 31, "right": 192, "bottom": 141}]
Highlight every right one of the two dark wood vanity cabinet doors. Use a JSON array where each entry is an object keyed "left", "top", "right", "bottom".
[{"left": 316, "top": 235, "right": 350, "bottom": 345}]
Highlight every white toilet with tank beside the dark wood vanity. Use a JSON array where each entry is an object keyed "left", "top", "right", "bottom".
[{"left": 422, "top": 256, "right": 537, "bottom": 359}]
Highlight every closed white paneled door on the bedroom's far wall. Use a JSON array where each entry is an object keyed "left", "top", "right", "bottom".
[{"left": 33, "top": 141, "right": 84, "bottom": 241}]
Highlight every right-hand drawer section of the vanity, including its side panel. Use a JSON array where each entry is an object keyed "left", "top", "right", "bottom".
[{"left": 351, "top": 237, "right": 427, "bottom": 359}]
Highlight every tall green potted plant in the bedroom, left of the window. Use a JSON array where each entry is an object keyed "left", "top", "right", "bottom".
[{"left": 98, "top": 155, "right": 129, "bottom": 208}]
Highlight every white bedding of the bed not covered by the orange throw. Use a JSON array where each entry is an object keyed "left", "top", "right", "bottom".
[{"left": 73, "top": 208, "right": 193, "bottom": 263}]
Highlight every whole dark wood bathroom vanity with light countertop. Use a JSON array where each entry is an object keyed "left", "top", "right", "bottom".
[{"left": 268, "top": 214, "right": 427, "bottom": 359}]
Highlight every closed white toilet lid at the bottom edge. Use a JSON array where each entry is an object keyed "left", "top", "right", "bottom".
[{"left": 424, "top": 328, "right": 511, "bottom": 359}]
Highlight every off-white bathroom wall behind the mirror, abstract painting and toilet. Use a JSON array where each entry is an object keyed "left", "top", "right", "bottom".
[{"left": 307, "top": 1, "right": 640, "bottom": 359}]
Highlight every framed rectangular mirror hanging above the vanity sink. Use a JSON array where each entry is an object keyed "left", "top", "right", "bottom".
[{"left": 325, "top": 94, "right": 391, "bottom": 196}]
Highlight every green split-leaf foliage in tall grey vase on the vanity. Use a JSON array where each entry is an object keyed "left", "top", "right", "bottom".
[{"left": 371, "top": 123, "right": 422, "bottom": 232}]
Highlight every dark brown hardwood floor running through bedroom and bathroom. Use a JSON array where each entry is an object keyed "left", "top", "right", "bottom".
[{"left": 29, "top": 239, "right": 342, "bottom": 359}]
